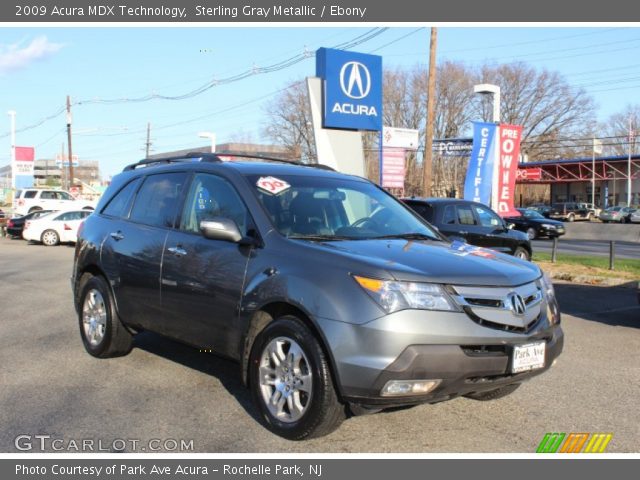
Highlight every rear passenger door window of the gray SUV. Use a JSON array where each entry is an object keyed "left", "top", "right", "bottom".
[{"left": 130, "top": 172, "right": 187, "bottom": 227}]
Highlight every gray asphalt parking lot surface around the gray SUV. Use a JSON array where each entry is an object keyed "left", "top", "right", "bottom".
[{"left": 0, "top": 238, "right": 640, "bottom": 453}]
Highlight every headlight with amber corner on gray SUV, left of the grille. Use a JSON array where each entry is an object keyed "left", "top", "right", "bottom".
[{"left": 353, "top": 275, "right": 460, "bottom": 313}]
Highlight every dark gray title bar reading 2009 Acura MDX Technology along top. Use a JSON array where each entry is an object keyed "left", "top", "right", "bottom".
[{"left": 0, "top": 0, "right": 640, "bottom": 23}]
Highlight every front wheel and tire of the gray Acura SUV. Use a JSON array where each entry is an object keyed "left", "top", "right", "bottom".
[{"left": 249, "top": 315, "right": 346, "bottom": 440}]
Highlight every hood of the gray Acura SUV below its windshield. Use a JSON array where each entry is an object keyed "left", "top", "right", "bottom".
[{"left": 304, "top": 239, "right": 541, "bottom": 286}]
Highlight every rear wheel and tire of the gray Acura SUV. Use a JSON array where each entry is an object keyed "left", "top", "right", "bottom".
[{"left": 78, "top": 275, "right": 133, "bottom": 358}]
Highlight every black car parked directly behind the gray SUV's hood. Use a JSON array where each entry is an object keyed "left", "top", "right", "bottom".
[{"left": 402, "top": 198, "right": 532, "bottom": 260}]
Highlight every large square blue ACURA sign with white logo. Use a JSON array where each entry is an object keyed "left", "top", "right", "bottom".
[{"left": 316, "top": 48, "right": 382, "bottom": 131}]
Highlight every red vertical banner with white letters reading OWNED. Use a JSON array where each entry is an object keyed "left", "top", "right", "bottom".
[{"left": 492, "top": 124, "right": 522, "bottom": 217}]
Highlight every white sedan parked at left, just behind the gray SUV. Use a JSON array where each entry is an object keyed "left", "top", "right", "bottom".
[{"left": 22, "top": 210, "right": 92, "bottom": 247}]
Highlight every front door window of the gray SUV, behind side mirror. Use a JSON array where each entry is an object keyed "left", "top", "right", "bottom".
[{"left": 182, "top": 173, "right": 248, "bottom": 234}]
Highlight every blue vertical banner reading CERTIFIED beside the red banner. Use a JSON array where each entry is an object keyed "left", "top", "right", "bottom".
[{"left": 464, "top": 122, "right": 498, "bottom": 205}]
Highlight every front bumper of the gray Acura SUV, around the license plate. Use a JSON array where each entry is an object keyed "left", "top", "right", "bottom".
[{"left": 321, "top": 302, "right": 564, "bottom": 408}]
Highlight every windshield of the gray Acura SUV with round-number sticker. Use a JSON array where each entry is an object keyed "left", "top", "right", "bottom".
[{"left": 247, "top": 175, "right": 441, "bottom": 240}]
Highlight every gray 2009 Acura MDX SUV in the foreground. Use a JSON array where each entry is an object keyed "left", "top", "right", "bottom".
[{"left": 72, "top": 154, "right": 563, "bottom": 439}]
